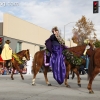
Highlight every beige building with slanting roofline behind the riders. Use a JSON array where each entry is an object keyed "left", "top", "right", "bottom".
[{"left": 0, "top": 13, "right": 76, "bottom": 56}]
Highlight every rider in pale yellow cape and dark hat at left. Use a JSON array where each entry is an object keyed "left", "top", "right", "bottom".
[{"left": 1, "top": 40, "right": 12, "bottom": 68}]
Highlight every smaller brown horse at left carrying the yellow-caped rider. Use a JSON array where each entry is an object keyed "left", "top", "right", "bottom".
[{"left": 1, "top": 49, "right": 30, "bottom": 80}]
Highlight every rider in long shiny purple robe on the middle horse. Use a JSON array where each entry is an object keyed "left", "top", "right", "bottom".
[{"left": 45, "top": 27, "right": 66, "bottom": 84}]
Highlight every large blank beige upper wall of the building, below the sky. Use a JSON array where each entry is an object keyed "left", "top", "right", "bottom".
[{"left": 3, "top": 13, "right": 51, "bottom": 45}]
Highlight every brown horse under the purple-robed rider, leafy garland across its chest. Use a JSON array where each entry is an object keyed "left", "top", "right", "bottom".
[{"left": 32, "top": 48, "right": 85, "bottom": 87}]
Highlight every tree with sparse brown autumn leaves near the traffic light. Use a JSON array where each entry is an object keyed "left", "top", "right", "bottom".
[{"left": 72, "top": 16, "right": 97, "bottom": 45}]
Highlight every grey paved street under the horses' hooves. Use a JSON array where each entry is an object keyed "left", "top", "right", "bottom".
[{"left": 0, "top": 72, "right": 100, "bottom": 100}]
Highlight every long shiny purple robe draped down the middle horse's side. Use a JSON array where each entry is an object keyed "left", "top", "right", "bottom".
[{"left": 45, "top": 38, "right": 66, "bottom": 84}]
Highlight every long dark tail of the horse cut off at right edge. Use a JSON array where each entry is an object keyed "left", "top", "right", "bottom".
[{"left": 88, "top": 51, "right": 95, "bottom": 79}]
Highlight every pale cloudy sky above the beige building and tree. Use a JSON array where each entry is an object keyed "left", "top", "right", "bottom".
[{"left": 0, "top": 0, "right": 100, "bottom": 39}]
